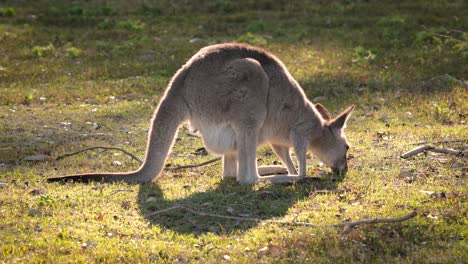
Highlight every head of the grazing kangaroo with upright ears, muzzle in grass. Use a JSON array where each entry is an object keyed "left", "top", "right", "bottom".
[{"left": 310, "top": 104, "right": 354, "bottom": 173}]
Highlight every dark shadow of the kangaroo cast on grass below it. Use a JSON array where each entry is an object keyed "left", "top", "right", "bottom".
[{"left": 138, "top": 174, "right": 342, "bottom": 235}]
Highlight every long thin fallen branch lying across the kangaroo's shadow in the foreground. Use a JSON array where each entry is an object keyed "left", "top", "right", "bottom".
[{"left": 146, "top": 204, "right": 417, "bottom": 228}]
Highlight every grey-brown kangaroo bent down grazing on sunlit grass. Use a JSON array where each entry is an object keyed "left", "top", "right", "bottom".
[{"left": 48, "top": 43, "right": 354, "bottom": 184}]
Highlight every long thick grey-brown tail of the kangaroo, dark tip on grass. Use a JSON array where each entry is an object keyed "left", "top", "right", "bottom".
[{"left": 47, "top": 77, "right": 190, "bottom": 183}]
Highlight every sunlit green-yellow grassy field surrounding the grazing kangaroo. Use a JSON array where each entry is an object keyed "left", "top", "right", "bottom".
[{"left": 0, "top": 0, "right": 468, "bottom": 263}]
